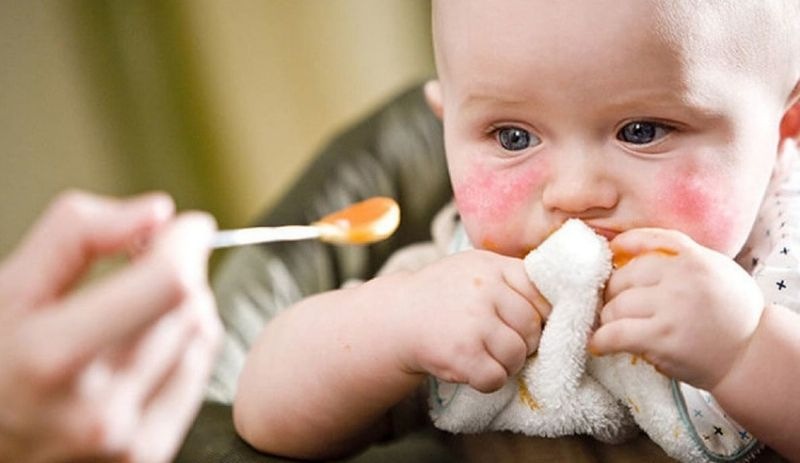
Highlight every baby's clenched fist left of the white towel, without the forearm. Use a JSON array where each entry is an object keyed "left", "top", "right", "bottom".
[{"left": 388, "top": 251, "right": 550, "bottom": 392}]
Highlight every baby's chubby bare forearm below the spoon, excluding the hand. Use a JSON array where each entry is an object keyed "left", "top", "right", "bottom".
[{"left": 234, "top": 280, "right": 423, "bottom": 457}]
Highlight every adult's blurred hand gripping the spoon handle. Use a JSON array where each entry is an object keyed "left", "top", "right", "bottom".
[{"left": 0, "top": 192, "right": 221, "bottom": 462}]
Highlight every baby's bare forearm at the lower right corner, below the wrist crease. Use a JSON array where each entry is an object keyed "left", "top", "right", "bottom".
[{"left": 712, "top": 306, "right": 800, "bottom": 461}]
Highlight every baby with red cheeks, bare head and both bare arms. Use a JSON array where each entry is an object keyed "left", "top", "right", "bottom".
[{"left": 234, "top": 0, "right": 800, "bottom": 459}]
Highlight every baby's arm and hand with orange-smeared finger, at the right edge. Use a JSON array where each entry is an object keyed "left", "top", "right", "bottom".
[{"left": 590, "top": 229, "right": 800, "bottom": 459}]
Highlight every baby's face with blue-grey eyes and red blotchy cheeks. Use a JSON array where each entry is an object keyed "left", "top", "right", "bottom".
[{"left": 435, "top": 0, "right": 788, "bottom": 256}]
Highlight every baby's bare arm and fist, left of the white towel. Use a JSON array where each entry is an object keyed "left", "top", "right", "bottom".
[{"left": 234, "top": 251, "right": 549, "bottom": 457}]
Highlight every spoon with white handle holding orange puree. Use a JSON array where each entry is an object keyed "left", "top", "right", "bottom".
[{"left": 211, "top": 196, "right": 400, "bottom": 249}]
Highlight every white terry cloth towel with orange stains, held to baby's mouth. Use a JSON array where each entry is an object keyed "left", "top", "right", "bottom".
[{"left": 430, "top": 219, "right": 754, "bottom": 462}]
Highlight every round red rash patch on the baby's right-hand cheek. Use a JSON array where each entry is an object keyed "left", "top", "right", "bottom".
[{"left": 652, "top": 165, "right": 739, "bottom": 253}]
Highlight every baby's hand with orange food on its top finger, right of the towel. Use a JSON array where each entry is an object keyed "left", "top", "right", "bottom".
[{"left": 589, "top": 228, "right": 764, "bottom": 390}]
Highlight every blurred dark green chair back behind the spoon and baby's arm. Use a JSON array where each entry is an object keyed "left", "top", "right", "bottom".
[{"left": 208, "top": 86, "right": 452, "bottom": 402}]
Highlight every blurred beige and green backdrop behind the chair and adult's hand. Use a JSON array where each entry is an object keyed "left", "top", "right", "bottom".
[{"left": 0, "top": 0, "right": 434, "bottom": 255}]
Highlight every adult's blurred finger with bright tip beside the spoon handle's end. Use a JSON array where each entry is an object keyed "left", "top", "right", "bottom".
[{"left": 30, "top": 213, "right": 216, "bottom": 380}]
